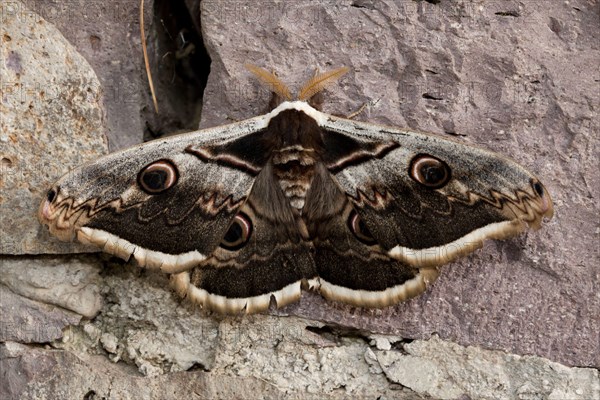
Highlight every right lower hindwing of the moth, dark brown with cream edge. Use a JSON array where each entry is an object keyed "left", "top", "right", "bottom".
[{"left": 303, "top": 165, "right": 438, "bottom": 308}]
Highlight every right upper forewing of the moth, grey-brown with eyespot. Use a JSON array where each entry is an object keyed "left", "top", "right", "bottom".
[{"left": 320, "top": 117, "right": 552, "bottom": 268}]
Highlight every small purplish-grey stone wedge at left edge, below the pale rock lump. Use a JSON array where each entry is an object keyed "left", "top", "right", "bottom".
[{"left": 0, "top": 285, "right": 81, "bottom": 343}]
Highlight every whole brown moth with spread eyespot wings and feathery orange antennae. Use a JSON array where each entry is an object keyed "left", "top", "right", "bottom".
[{"left": 39, "top": 66, "right": 553, "bottom": 314}]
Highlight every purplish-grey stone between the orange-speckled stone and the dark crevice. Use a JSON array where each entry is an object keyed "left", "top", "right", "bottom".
[{"left": 24, "top": 0, "right": 145, "bottom": 151}]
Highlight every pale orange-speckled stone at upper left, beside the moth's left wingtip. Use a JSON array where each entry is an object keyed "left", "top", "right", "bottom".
[{"left": 0, "top": 1, "right": 107, "bottom": 254}]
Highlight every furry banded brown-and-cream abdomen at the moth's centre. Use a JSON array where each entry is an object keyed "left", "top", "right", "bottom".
[{"left": 273, "top": 145, "right": 315, "bottom": 212}]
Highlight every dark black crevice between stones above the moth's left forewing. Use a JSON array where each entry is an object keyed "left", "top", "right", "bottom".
[{"left": 144, "top": 0, "right": 211, "bottom": 140}]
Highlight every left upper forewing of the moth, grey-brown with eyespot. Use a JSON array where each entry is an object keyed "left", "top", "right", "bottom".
[{"left": 40, "top": 117, "right": 274, "bottom": 272}]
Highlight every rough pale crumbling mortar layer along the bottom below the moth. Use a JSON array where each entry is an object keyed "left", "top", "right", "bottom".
[{"left": 0, "top": 263, "right": 600, "bottom": 400}]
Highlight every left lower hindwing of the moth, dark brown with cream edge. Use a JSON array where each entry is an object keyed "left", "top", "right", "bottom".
[{"left": 172, "top": 163, "right": 317, "bottom": 314}]
